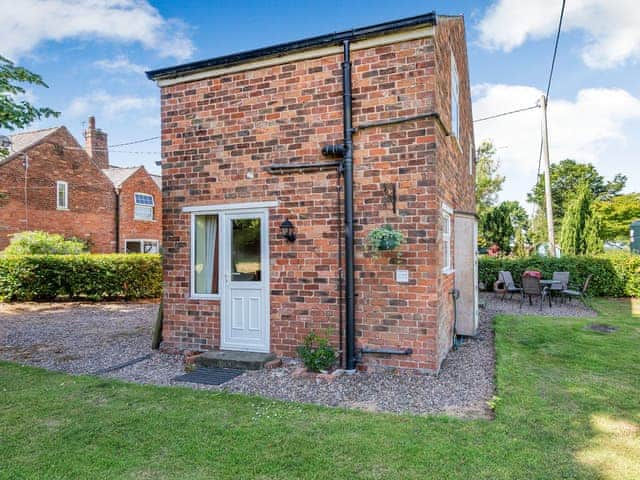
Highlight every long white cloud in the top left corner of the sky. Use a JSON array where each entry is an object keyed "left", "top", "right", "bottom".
[{"left": 0, "top": 0, "right": 194, "bottom": 60}]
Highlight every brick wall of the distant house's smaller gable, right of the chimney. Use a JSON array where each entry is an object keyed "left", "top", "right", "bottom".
[{"left": 119, "top": 167, "right": 162, "bottom": 253}]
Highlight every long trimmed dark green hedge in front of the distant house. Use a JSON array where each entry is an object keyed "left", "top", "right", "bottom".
[{"left": 0, "top": 253, "right": 162, "bottom": 302}]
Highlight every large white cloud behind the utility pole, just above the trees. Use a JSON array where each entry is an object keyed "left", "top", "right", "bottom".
[{"left": 472, "top": 84, "right": 640, "bottom": 201}]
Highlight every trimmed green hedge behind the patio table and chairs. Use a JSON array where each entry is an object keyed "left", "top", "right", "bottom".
[{"left": 478, "top": 252, "right": 640, "bottom": 297}]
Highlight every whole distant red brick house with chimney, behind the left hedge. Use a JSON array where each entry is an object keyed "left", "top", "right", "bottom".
[{"left": 0, "top": 117, "right": 162, "bottom": 253}]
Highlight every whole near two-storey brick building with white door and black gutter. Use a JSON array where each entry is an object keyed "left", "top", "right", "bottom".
[{"left": 148, "top": 13, "right": 477, "bottom": 371}]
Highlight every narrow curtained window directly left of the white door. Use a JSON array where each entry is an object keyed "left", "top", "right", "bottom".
[{"left": 191, "top": 214, "right": 219, "bottom": 297}]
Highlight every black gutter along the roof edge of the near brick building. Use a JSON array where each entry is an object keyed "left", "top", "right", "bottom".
[{"left": 146, "top": 12, "right": 436, "bottom": 80}]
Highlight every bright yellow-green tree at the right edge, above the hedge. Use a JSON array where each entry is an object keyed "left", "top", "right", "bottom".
[{"left": 594, "top": 193, "right": 640, "bottom": 240}]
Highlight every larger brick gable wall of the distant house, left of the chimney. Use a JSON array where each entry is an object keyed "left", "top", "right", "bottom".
[{"left": 0, "top": 127, "right": 115, "bottom": 253}]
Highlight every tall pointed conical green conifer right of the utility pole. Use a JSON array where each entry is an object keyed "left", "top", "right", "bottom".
[{"left": 560, "top": 184, "right": 602, "bottom": 255}]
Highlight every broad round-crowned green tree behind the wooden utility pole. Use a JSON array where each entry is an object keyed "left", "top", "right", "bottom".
[{"left": 527, "top": 159, "right": 627, "bottom": 222}]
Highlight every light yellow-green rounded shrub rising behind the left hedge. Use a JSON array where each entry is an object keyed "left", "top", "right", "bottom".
[{"left": 3, "top": 231, "right": 87, "bottom": 255}]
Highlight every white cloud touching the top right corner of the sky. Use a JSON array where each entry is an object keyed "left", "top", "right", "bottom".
[{"left": 478, "top": 0, "right": 640, "bottom": 68}]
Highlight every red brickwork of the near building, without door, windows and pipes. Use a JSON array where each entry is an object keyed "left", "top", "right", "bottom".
[{"left": 151, "top": 13, "right": 475, "bottom": 372}]
